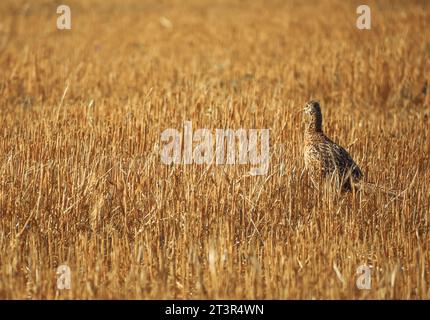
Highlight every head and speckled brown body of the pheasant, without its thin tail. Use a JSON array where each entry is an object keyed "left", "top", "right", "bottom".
[{"left": 303, "top": 100, "right": 363, "bottom": 191}]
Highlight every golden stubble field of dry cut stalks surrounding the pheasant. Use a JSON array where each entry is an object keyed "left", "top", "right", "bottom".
[{"left": 0, "top": 0, "right": 430, "bottom": 299}]
